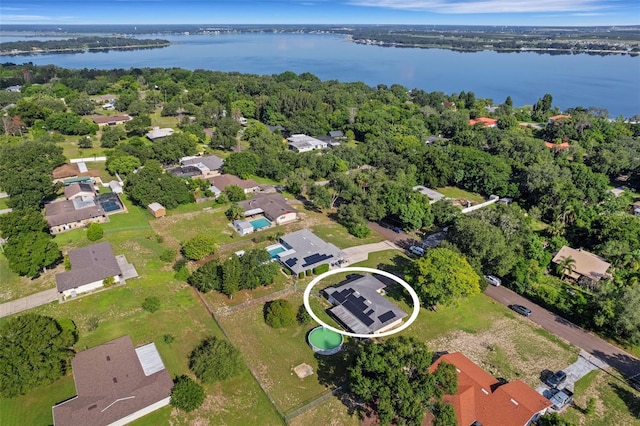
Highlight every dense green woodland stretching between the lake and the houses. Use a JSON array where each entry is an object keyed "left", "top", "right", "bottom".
[{"left": 0, "top": 64, "right": 640, "bottom": 360}]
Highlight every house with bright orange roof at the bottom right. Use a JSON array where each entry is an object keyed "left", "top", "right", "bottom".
[{"left": 429, "top": 352, "right": 553, "bottom": 426}]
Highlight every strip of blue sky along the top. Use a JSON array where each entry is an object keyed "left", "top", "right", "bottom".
[{"left": 0, "top": 0, "right": 640, "bottom": 26}]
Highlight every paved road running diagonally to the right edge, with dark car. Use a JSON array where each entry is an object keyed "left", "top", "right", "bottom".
[{"left": 485, "top": 285, "right": 640, "bottom": 383}]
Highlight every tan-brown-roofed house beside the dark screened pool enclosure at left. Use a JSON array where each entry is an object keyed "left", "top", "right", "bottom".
[{"left": 44, "top": 197, "right": 109, "bottom": 234}]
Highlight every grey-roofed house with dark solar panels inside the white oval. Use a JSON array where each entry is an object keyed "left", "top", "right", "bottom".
[{"left": 324, "top": 274, "right": 407, "bottom": 334}]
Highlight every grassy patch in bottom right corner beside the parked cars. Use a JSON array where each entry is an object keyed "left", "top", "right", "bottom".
[{"left": 563, "top": 370, "right": 640, "bottom": 426}]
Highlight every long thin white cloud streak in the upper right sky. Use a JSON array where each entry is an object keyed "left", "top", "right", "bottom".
[{"left": 349, "top": 0, "right": 604, "bottom": 14}]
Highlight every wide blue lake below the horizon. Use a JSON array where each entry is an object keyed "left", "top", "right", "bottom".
[{"left": 0, "top": 33, "right": 640, "bottom": 117}]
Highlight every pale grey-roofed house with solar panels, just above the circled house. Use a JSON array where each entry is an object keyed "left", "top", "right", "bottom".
[{"left": 278, "top": 229, "right": 345, "bottom": 275}]
